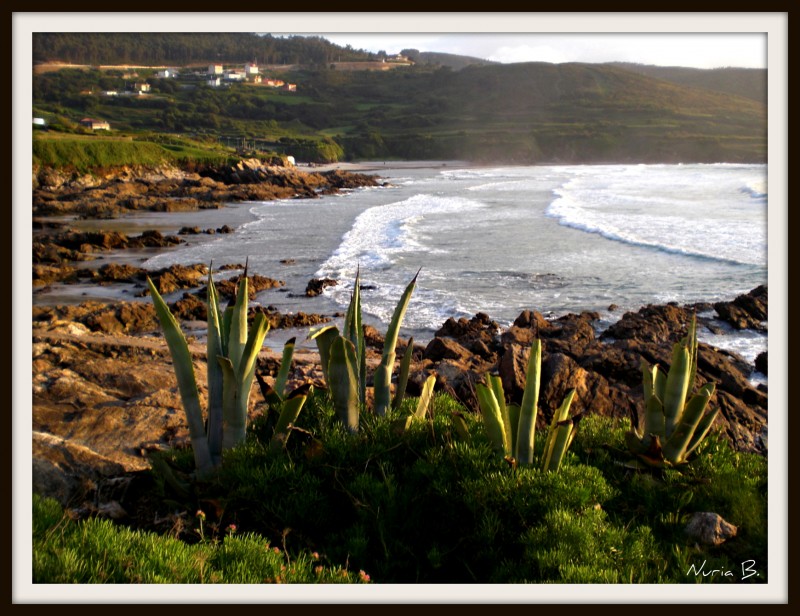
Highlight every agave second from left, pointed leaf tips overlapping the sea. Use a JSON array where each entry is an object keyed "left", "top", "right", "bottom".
[{"left": 309, "top": 272, "right": 419, "bottom": 432}]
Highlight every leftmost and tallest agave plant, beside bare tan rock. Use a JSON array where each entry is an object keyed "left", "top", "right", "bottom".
[{"left": 147, "top": 267, "right": 278, "bottom": 478}]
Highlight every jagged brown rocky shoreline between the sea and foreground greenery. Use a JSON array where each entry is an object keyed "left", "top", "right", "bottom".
[{"left": 32, "top": 159, "right": 768, "bottom": 517}]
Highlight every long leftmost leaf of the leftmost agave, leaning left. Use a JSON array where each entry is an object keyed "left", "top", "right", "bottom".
[{"left": 147, "top": 276, "right": 214, "bottom": 475}]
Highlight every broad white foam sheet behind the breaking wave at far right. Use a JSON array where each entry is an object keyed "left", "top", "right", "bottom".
[{"left": 546, "top": 166, "right": 766, "bottom": 265}]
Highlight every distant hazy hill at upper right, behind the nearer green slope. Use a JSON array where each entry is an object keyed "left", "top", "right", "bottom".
[{"left": 608, "top": 62, "right": 767, "bottom": 104}]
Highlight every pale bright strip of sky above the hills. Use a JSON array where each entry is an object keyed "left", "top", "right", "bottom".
[{"left": 296, "top": 32, "right": 767, "bottom": 68}]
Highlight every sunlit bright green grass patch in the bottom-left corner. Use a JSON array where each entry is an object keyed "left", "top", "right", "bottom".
[{"left": 33, "top": 495, "right": 368, "bottom": 584}]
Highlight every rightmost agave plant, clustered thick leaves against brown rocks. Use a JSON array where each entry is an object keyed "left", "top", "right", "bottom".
[{"left": 626, "top": 317, "right": 719, "bottom": 467}]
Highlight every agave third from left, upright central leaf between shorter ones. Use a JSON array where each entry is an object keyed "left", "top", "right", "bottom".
[{"left": 476, "top": 340, "right": 580, "bottom": 471}]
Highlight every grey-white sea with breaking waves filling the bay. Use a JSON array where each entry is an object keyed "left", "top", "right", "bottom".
[{"left": 144, "top": 162, "right": 769, "bottom": 376}]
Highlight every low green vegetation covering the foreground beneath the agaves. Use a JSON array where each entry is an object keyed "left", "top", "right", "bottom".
[{"left": 33, "top": 392, "right": 768, "bottom": 584}]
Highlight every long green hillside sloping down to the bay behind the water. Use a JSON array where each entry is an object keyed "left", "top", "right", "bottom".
[{"left": 33, "top": 37, "right": 767, "bottom": 163}]
